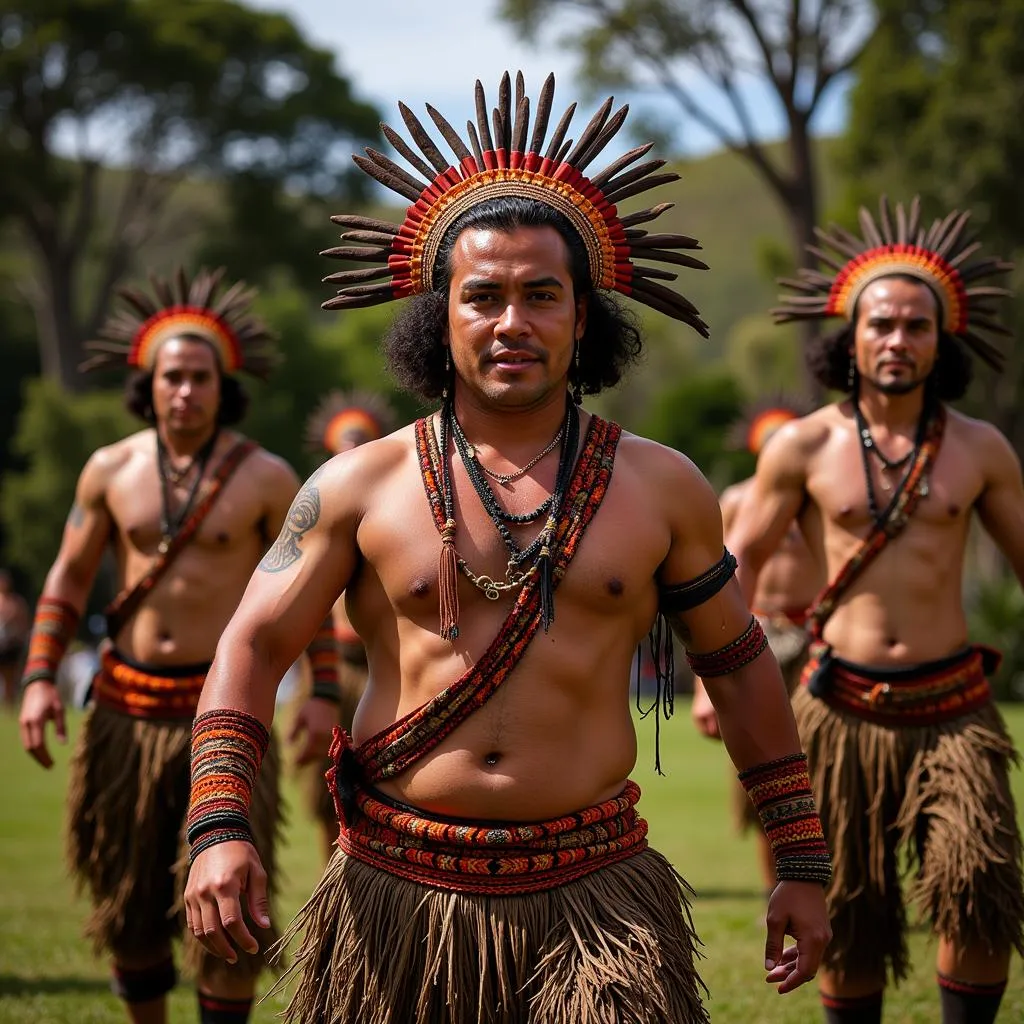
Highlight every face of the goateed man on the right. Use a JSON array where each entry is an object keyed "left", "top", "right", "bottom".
[{"left": 854, "top": 278, "right": 939, "bottom": 394}]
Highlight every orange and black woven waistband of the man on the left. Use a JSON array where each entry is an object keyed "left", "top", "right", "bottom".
[{"left": 92, "top": 647, "right": 210, "bottom": 719}]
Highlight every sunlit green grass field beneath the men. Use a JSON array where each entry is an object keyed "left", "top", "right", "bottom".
[{"left": 0, "top": 707, "right": 1024, "bottom": 1024}]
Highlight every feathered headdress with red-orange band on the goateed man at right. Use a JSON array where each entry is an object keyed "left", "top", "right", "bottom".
[{"left": 772, "top": 196, "right": 1013, "bottom": 370}]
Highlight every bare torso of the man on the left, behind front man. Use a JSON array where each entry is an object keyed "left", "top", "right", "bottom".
[{"left": 105, "top": 430, "right": 276, "bottom": 666}]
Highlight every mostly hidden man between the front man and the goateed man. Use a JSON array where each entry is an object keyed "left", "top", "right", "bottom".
[{"left": 690, "top": 394, "right": 824, "bottom": 893}]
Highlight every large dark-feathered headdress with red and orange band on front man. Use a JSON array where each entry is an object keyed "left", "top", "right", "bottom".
[{"left": 323, "top": 72, "right": 708, "bottom": 337}]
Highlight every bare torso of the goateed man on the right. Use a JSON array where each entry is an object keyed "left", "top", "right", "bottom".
[{"left": 801, "top": 404, "right": 985, "bottom": 666}]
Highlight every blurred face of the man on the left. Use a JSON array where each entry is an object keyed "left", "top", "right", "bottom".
[{"left": 153, "top": 338, "right": 220, "bottom": 434}]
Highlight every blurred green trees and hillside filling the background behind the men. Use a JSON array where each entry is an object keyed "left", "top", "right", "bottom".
[{"left": 0, "top": 0, "right": 1024, "bottom": 693}]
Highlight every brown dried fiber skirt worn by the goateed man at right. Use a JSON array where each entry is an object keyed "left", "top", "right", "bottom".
[{"left": 794, "top": 686, "right": 1024, "bottom": 980}]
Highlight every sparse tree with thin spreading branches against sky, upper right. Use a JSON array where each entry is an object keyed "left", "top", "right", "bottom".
[{"left": 501, "top": 0, "right": 871, "bottom": 360}]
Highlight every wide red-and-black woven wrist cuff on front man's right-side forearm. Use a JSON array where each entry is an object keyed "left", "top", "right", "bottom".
[{"left": 739, "top": 754, "right": 831, "bottom": 886}]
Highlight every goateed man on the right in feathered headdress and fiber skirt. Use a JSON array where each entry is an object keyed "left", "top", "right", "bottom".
[{"left": 730, "top": 200, "right": 1024, "bottom": 1024}]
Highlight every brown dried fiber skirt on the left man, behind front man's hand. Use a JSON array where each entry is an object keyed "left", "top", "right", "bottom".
[{"left": 68, "top": 706, "right": 281, "bottom": 978}]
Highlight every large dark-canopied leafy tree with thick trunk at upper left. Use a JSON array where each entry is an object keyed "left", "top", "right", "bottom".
[{"left": 0, "top": 0, "right": 377, "bottom": 390}]
